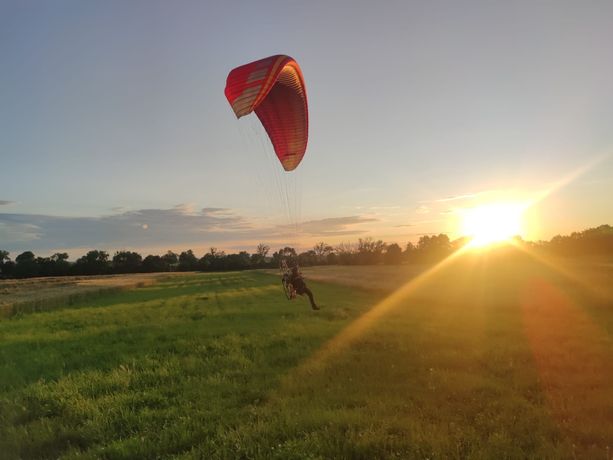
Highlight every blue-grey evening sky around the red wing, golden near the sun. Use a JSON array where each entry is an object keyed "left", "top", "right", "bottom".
[{"left": 0, "top": 0, "right": 613, "bottom": 258}]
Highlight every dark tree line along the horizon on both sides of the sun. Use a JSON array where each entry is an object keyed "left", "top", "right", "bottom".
[{"left": 0, "top": 225, "right": 613, "bottom": 278}]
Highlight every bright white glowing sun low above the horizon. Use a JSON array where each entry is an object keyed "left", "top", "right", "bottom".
[{"left": 460, "top": 203, "right": 526, "bottom": 247}]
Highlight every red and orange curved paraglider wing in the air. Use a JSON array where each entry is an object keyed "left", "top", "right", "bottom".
[{"left": 225, "top": 55, "right": 309, "bottom": 171}]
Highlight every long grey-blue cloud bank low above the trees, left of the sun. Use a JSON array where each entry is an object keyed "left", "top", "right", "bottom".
[{"left": 0, "top": 208, "right": 378, "bottom": 256}]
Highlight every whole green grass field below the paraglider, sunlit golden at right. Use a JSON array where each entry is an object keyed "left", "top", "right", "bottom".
[{"left": 0, "top": 252, "right": 613, "bottom": 459}]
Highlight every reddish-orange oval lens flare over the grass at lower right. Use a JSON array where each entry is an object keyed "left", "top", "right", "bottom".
[{"left": 520, "top": 278, "right": 613, "bottom": 448}]
